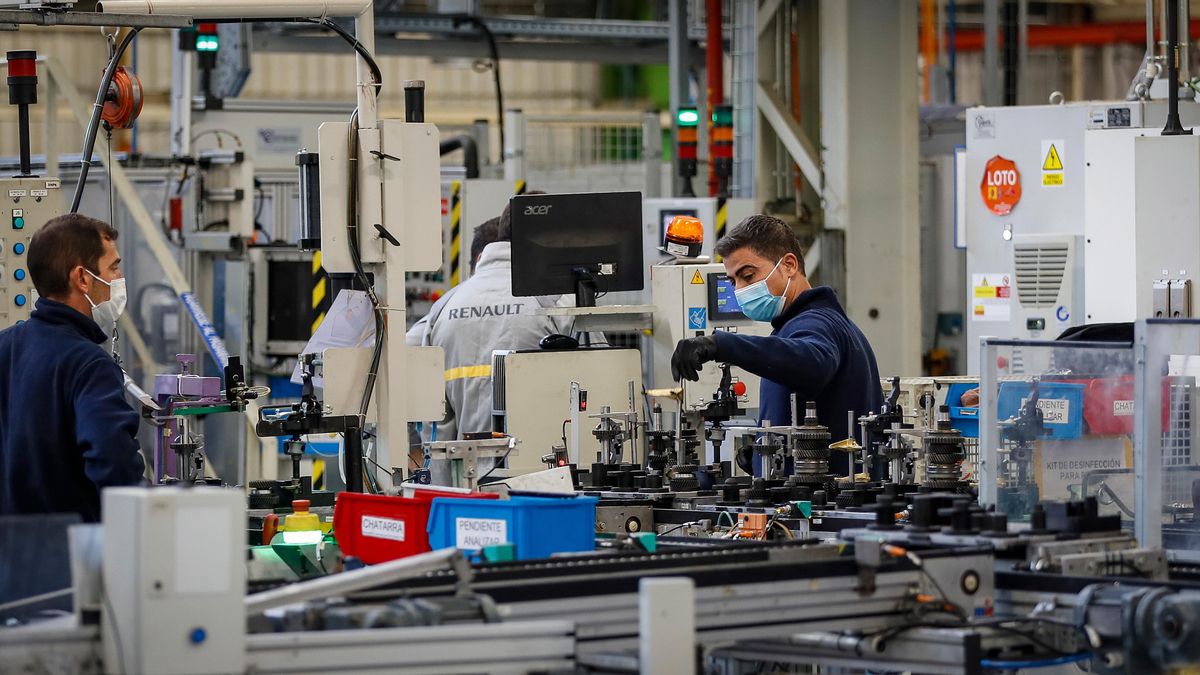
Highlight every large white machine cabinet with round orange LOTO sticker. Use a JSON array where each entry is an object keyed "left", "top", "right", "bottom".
[{"left": 959, "top": 100, "right": 1200, "bottom": 374}]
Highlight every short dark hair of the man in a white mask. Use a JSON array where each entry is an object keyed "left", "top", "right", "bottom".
[{"left": 29, "top": 214, "right": 116, "bottom": 298}]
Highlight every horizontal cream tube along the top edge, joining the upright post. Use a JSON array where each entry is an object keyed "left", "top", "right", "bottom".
[{"left": 96, "top": 0, "right": 371, "bottom": 20}]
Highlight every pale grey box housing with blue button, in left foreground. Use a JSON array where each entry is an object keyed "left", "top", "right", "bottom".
[{"left": 102, "top": 488, "right": 246, "bottom": 675}]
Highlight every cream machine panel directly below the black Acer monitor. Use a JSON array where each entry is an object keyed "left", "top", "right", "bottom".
[{"left": 492, "top": 347, "right": 642, "bottom": 474}]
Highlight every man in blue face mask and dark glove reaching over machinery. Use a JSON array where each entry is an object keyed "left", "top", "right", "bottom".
[{"left": 671, "top": 215, "right": 883, "bottom": 474}]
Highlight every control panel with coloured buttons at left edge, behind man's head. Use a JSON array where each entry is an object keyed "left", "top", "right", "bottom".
[{"left": 0, "top": 178, "right": 62, "bottom": 329}]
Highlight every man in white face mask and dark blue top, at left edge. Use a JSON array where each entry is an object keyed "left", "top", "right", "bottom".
[{"left": 0, "top": 214, "right": 145, "bottom": 522}]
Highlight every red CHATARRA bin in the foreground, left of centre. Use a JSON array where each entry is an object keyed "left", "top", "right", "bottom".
[{"left": 334, "top": 482, "right": 499, "bottom": 565}]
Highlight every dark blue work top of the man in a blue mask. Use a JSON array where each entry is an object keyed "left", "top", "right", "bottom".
[{"left": 713, "top": 286, "right": 883, "bottom": 476}]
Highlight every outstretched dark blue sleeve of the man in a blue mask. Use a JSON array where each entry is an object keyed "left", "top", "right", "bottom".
[{"left": 713, "top": 328, "right": 841, "bottom": 395}]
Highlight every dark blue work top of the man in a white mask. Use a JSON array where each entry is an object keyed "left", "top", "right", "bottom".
[{"left": 0, "top": 298, "right": 144, "bottom": 522}]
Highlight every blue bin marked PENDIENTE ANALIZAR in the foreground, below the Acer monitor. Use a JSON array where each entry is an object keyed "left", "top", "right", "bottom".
[{"left": 428, "top": 496, "right": 599, "bottom": 560}]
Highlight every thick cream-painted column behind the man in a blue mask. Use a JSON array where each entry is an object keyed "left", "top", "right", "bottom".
[{"left": 821, "top": 0, "right": 922, "bottom": 376}]
